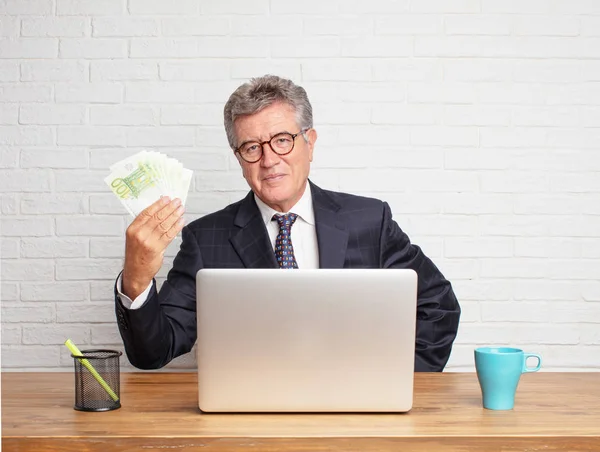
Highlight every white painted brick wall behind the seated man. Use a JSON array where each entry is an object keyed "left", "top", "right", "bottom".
[{"left": 0, "top": 0, "right": 600, "bottom": 370}]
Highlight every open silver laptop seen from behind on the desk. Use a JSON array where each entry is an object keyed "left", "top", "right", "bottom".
[{"left": 196, "top": 269, "right": 417, "bottom": 412}]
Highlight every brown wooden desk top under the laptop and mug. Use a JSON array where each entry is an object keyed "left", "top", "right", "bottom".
[{"left": 2, "top": 372, "right": 600, "bottom": 452}]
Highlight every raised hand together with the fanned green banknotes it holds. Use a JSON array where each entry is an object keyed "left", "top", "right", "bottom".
[{"left": 104, "top": 151, "right": 192, "bottom": 300}]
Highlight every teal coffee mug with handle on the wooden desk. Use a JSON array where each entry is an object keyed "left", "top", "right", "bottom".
[{"left": 475, "top": 347, "right": 542, "bottom": 410}]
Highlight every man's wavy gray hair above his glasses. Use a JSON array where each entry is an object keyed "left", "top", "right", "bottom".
[{"left": 223, "top": 75, "right": 313, "bottom": 149}]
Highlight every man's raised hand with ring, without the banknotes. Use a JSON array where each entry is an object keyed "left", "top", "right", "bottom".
[{"left": 121, "top": 196, "right": 184, "bottom": 300}]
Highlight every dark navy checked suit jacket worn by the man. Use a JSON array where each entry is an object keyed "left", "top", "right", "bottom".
[{"left": 115, "top": 183, "right": 460, "bottom": 372}]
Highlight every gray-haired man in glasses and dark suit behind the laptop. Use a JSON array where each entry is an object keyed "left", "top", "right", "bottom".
[{"left": 115, "top": 75, "right": 460, "bottom": 371}]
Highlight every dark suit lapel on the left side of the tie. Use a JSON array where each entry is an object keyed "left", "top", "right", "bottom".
[{"left": 229, "top": 192, "right": 278, "bottom": 268}]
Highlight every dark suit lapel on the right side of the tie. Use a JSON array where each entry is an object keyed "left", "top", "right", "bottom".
[{"left": 309, "top": 181, "right": 348, "bottom": 268}]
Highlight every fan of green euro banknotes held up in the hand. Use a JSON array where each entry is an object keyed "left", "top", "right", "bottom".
[{"left": 104, "top": 151, "right": 193, "bottom": 217}]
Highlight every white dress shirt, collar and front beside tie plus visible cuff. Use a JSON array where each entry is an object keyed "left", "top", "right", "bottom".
[{"left": 117, "top": 182, "right": 319, "bottom": 309}]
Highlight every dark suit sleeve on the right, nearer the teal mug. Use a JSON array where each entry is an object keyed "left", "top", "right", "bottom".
[{"left": 380, "top": 203, "right": 460, "bottom": 372}]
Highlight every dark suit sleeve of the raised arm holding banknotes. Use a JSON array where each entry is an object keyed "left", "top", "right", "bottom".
[{"left": 115, "top": 227, "right": 203, "bottom": 369}]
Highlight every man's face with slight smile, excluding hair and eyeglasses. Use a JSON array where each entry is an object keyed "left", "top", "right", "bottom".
[{"left": 234, "top": 103, "right": 317, "bottom": 212}]
